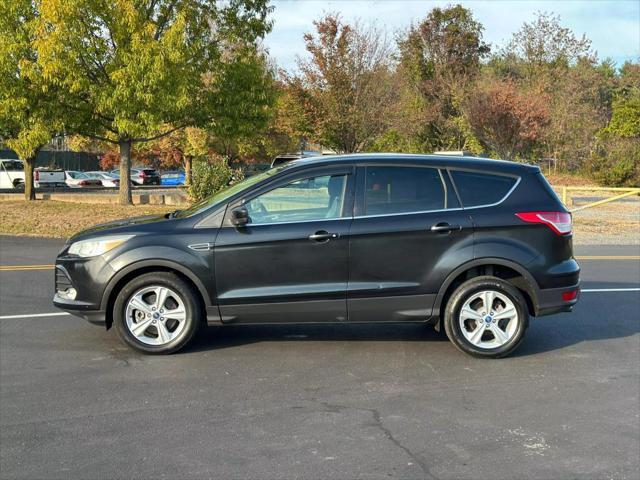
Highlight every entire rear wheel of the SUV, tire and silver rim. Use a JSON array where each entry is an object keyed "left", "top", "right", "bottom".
[{"left": 444, "top": 276, "right": 529, "bottom": 358}]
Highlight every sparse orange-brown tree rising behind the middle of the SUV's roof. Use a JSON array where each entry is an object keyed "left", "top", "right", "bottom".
[{"left": 288, "top": 14, "right": 395, "bottom": 153}]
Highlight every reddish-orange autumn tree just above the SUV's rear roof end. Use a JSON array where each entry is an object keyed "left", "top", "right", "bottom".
[{"left": 466, "top": 80, "right": 549, "bottom": 159}]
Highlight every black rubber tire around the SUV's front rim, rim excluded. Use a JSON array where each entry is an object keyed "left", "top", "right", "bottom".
[{"left": 113, "top": 272, "right": 203, "bottom": 355}]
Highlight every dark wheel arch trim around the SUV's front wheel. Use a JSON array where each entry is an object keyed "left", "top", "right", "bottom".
[{"left": 100, "top": 259, "right": 211, "bottom": 330}]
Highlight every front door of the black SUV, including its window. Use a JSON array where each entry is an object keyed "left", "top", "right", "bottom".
[{"left": 214, "top": 167, "right": 354, "bottom": 323}]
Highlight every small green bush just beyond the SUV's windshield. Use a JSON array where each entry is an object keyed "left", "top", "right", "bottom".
[{"left": 189, "top": 157, "right": 244, "bottom": 202}]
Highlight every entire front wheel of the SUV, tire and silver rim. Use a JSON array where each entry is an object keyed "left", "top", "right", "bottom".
[{"left": 113, "top": 272, "right": 203, "bottom": 355}]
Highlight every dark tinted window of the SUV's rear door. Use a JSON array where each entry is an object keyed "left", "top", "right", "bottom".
[{"left": 365, "top": 167, "right": 445, "bottom": 215}]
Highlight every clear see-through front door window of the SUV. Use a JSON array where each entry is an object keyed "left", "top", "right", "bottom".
[{"left": 245, "top": 174, "right": 347, "bottom": 225}]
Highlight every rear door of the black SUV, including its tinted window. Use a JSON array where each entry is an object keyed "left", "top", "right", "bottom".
[{"left": 347, "top": 164, "right": 473, "bottom": 322}]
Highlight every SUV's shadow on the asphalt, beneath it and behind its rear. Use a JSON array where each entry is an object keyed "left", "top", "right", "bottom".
[{"left": 185, "top": 282, "right": 640, "bottom": 357}]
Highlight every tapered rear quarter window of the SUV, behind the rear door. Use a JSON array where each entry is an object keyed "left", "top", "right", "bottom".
[{"left": 451, "top": 170, "right": 516, "bottom": 207}]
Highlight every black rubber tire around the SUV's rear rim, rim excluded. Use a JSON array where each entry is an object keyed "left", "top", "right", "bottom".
[{"left": 444, "top": 276, "right": 529, "bottom": 358}]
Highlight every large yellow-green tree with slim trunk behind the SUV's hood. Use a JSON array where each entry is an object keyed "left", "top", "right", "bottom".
[{"left": 35, "top": 0, "right": 270, "bottom": 204}]
